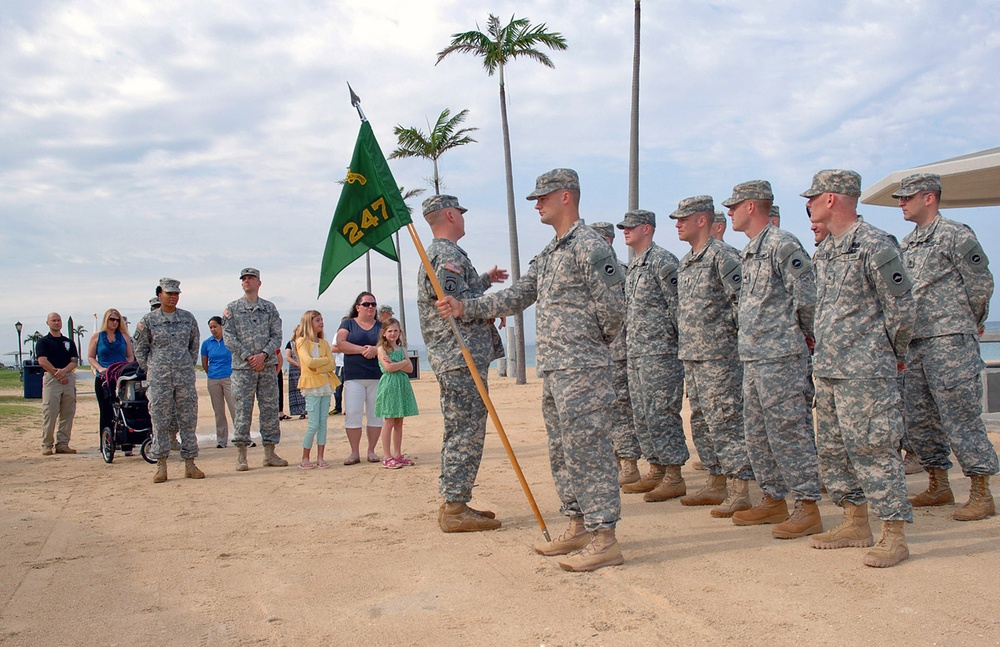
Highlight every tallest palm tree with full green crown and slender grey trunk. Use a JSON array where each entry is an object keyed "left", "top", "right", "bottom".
[{"left": 435, "top": 14, "right": 566, "bottom": 384}]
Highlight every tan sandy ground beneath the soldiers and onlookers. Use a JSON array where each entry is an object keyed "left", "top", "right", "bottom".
[{"left": 0, "top": 373, "right": 1000, "bottom": 646}]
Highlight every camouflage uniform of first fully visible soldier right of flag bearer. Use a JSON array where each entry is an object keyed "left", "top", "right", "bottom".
[{"left": 625, "top": 243, "right": 690, "bottom": 465}]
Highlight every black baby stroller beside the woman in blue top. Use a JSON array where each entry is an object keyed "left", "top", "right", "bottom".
[{"left": 101, "top": 362, "right": 156, "bottom": 463}]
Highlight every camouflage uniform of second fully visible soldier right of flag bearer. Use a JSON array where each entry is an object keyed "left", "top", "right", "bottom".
[{"left": 677, "top": 238, "right": 753, "bottom": 480}]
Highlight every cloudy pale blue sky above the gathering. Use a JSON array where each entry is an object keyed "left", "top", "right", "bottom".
[{"left": 0, "top": 0, "right": 1000, "bottom": 361}]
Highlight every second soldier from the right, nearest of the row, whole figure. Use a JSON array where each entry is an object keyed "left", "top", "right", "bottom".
[{"left": 802, "top": 169, "right": 914, "bottom": 568}]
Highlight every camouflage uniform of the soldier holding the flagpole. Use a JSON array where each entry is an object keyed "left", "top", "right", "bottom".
[{"left": 463, "top": 221, "right": 625, "bottom": 531}]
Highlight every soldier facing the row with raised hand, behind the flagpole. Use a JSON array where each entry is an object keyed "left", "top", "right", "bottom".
[{"left": 417, "top": 195, "right": 507, "bottom": 532}]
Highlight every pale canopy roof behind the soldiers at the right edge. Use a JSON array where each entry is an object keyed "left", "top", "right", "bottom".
[{"left": 861, "top": 148, "right": 1000, "bottom": 209}]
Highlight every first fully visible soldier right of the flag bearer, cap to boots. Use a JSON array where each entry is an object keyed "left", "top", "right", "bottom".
[{"left": 618, "top": 210, "right": 690, "bottom": 502}]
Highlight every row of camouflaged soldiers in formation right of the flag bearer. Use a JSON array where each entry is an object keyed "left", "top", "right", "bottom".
[{"left": 592, "top": 170, "right": 997, "bottom": 566}]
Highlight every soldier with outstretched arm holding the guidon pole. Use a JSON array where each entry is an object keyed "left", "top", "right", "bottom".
[{"left": 437, "top": 169, "right": 625, "bottom": 571}]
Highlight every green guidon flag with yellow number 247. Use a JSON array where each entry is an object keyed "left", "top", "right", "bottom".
[{"left": 319, "top": 121, "right": 412, "bottom": 295}]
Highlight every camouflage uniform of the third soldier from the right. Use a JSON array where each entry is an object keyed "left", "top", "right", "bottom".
[{"left": 739, "top": 224, "right": 820, "bottom": 501}]
